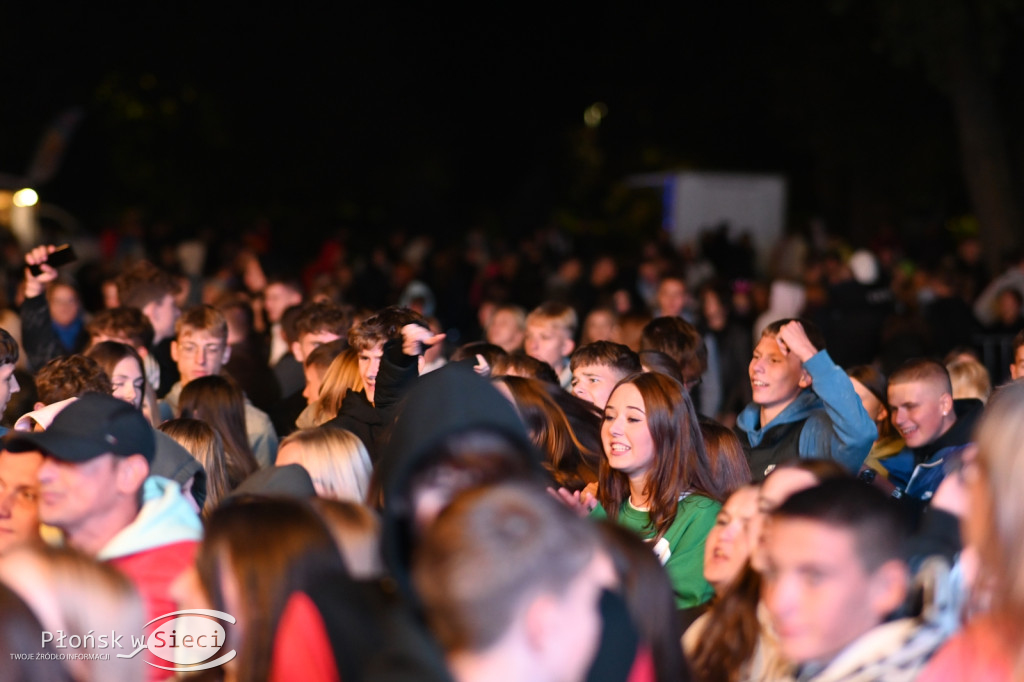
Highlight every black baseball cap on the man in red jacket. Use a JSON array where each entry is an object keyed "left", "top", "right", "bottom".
[{"left": 4, "top": 393, "right": 157, "bottom": 463}]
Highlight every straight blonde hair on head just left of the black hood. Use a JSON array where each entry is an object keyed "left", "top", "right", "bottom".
[{"left": 278, "top": 428, "right": 372, "bottom": 502}]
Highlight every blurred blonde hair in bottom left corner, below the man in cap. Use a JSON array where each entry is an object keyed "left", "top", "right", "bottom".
[{"left": 0, "top": 546, "right": 145, "bottom": 682}]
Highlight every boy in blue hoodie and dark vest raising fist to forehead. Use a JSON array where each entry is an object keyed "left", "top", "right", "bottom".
[{"left": 736, "top": 318, "right": 878, "bottom": 482}]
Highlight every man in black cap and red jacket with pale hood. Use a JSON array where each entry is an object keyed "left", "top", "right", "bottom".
[{"left": 6, "top": 393, "right": 203, "bottom": 620}]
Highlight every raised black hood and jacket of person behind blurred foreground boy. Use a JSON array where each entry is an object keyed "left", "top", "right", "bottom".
[{"left": 310, "top": 361, "right": 543, "bottom": 682}]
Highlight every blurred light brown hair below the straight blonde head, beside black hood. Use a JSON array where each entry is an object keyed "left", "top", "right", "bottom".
[{"left": 311, "top": 498, "right": 384, "bottom": 580}]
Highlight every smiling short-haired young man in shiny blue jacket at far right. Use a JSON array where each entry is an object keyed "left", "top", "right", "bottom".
[{"left": 883, "top": 359, "right": 984, "bottom": 502}]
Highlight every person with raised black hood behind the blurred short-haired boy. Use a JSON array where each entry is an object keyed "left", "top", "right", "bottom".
[{"left": 310, "top": 363, "right": 651, "bottom": 682}]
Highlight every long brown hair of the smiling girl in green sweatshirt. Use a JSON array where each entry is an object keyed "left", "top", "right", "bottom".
[{"left": 598, "top": 372, "right": 722, "bottom": 539}]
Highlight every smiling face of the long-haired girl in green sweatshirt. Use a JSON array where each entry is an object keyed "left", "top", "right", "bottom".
[{"left": 601, "top": 384, "right": 654, "bottom": 476}]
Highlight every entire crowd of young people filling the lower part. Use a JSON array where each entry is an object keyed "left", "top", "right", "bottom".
[{"left": 0, "top": 222, "right": 1024, "bottom": 682}]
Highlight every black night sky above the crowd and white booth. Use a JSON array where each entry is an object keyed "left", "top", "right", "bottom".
[{"left": 0, "top": 0, "right": 1020, "bottom": 246}]
